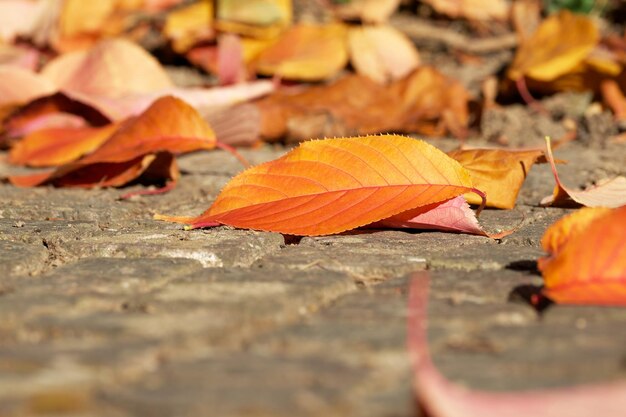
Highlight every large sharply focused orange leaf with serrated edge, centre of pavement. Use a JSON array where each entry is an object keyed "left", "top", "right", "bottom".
[{"left": 156, "top": 135, "right": 472, "bottom": 235}]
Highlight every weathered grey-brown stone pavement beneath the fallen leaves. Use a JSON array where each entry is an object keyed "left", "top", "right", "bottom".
[{"left": 0, "top": 141, "right": 626, "bottom": 417}]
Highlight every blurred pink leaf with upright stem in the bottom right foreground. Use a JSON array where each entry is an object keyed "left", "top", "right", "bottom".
[{"left": 407, "top": 272, "right": 626, "bottom": 417}]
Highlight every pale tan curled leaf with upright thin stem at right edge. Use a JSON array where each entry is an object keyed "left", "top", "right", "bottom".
[{"left": 541, "top": 137, "right": 626, "bottom": 208}]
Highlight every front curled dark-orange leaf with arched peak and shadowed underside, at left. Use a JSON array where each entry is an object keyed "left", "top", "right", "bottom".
[{"left": 9, "top": 96, "right": 215, "bottom": 188}]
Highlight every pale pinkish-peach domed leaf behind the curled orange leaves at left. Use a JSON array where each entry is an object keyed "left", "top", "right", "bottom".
[{"left": 41, "top": 39, "right": 173, "bottom": 97}]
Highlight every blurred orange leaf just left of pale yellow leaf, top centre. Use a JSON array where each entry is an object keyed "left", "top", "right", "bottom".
[{"left": 254, "top": 23, "right": 348, "bottom": 81}]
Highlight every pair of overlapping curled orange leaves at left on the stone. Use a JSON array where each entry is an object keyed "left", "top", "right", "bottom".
[{"left": 9, "top": 96, "right": 215, "bottom": 188}]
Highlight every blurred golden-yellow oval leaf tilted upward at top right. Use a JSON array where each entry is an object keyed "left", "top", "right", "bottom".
[{"left": 508, "top": 10, "right": 600, "bottom": 81}]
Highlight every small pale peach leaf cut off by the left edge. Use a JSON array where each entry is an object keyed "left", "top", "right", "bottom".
[{"left": 0, "top": 65, "right": 56, "bottom": 106}]
